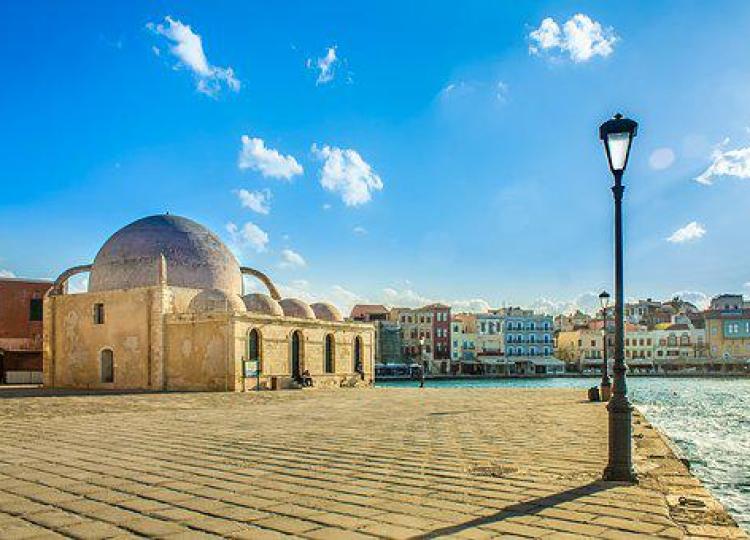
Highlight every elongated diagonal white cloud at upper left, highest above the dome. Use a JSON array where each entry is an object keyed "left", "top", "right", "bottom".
[{"left": 146, "top": 16, "right": 240, "bottom": 97}]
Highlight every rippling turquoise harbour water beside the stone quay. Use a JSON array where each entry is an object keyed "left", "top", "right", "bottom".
[{"left": 378, "top": 377, "right": 750, "bottom": 530}]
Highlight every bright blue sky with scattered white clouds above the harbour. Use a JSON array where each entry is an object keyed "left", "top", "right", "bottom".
[{"left": 0, "top": 1, "right": 750, "bottom": 311}]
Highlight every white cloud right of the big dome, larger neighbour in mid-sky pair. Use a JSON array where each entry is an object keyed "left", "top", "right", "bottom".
[{"left": 312, "top": 144, "right": 383, "bottom": 206}]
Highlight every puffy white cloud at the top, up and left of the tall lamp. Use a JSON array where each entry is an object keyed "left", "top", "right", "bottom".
[{"left": 529, "top": 13, "right": 618, "bottom": 63}]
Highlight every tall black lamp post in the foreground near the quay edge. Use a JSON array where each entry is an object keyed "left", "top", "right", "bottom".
[{"left": 599, "top": 113, "right": 638, "bottom": 482}]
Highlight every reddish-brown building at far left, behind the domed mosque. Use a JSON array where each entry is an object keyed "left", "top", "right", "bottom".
[{"left": 0, "top": 277, "right": 52, "bottom": 384}]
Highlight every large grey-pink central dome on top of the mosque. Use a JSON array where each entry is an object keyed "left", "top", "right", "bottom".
[{"left": 89, "top": 214, "right": 242, "bottom": 294}]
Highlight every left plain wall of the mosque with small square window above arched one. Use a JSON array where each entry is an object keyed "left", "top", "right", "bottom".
[{"left": 44, "top": 288, "right": 151, "bottom": 389}]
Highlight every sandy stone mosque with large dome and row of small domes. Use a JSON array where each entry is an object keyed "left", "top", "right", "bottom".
[{"left": 44, "top": 214, "right": 375, "bottom": 391}]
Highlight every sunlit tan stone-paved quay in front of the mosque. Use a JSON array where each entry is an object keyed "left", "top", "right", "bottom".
[{"left": 0, "top": 388, "right": 744, "bottom": 539}]
